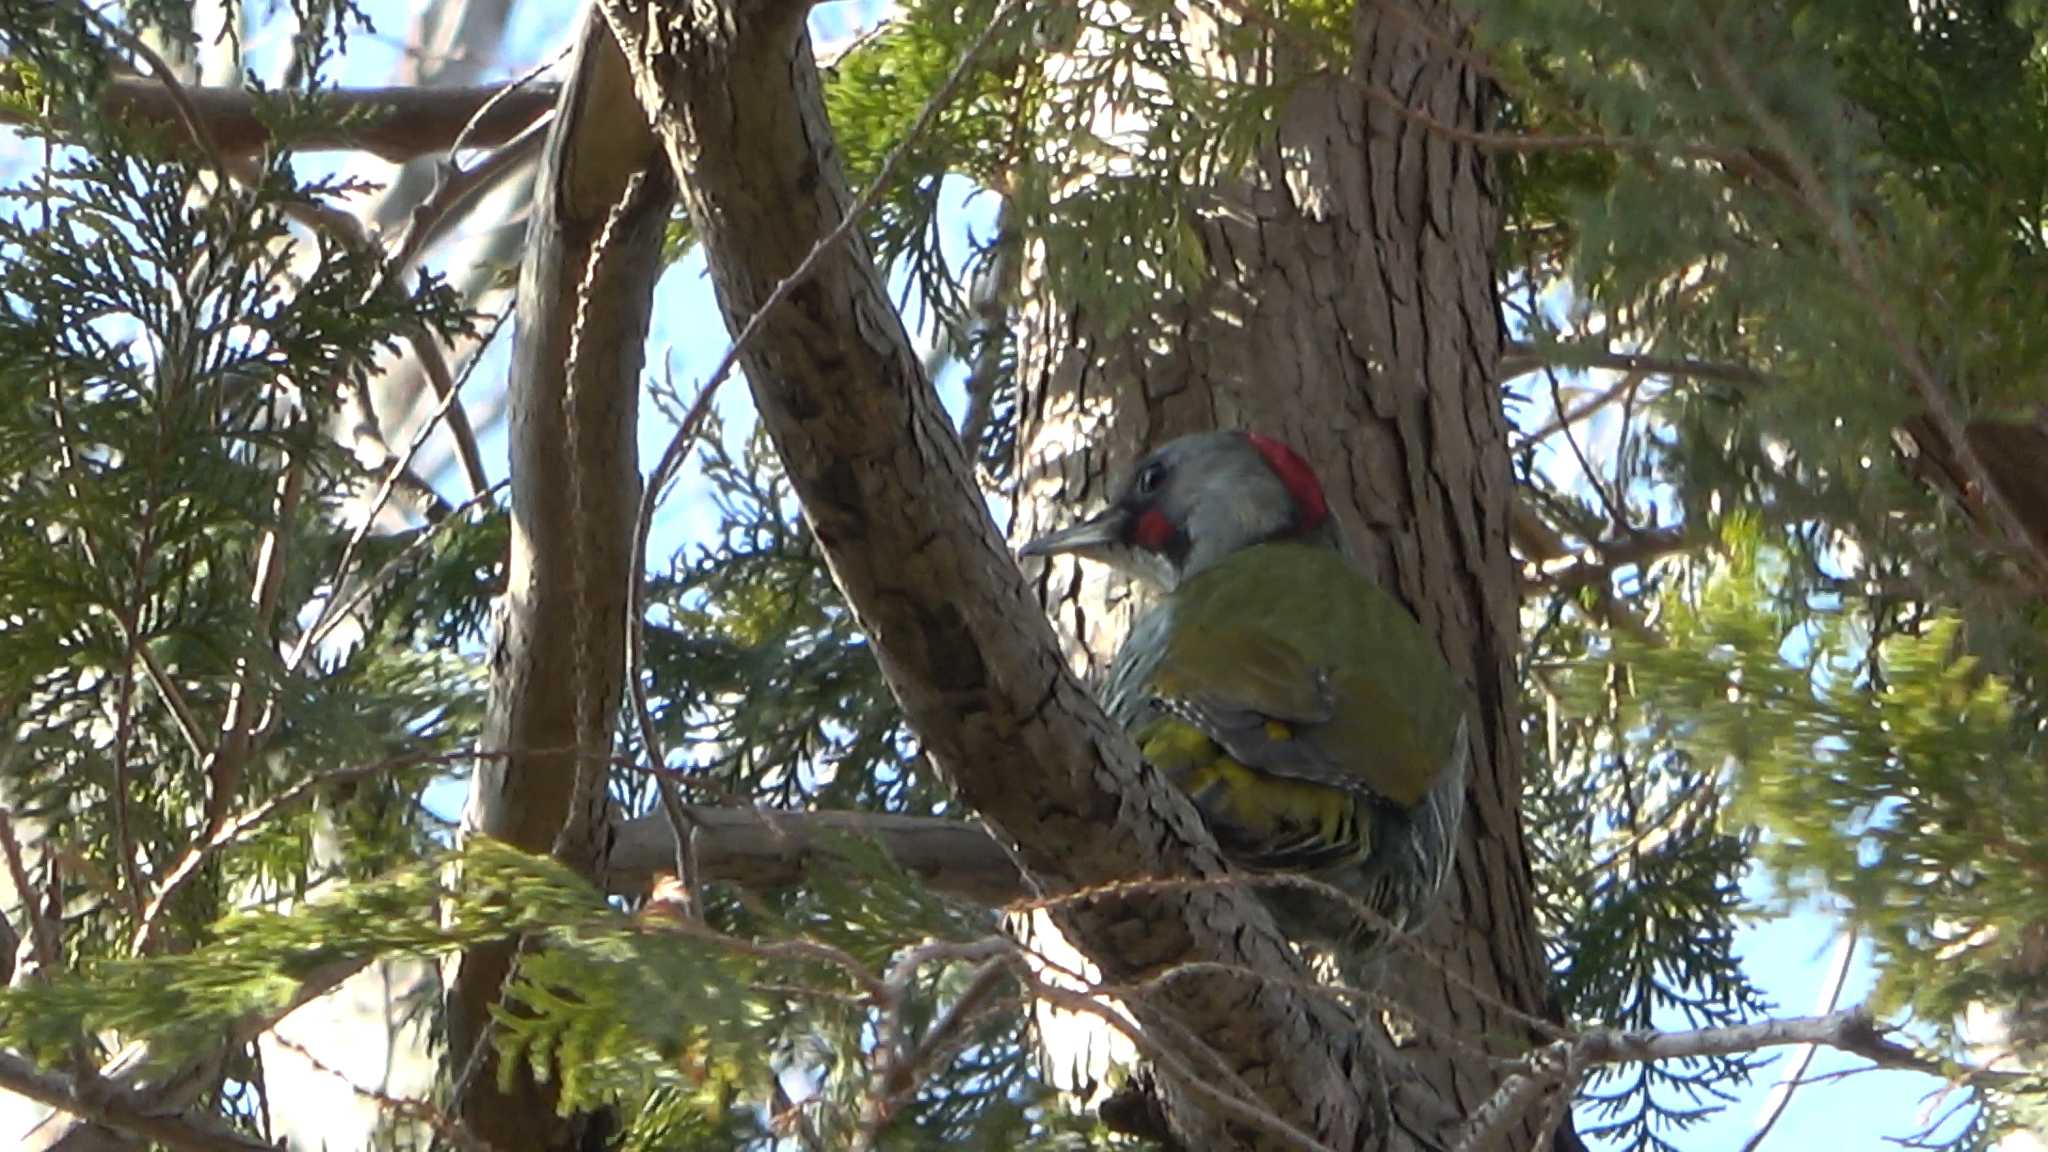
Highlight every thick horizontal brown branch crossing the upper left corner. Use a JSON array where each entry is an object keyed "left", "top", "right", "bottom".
[{"left": 0, "top": 76, "right": 559, "bottom": 162}]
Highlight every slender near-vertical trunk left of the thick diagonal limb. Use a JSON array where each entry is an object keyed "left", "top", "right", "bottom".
[{"left": 449, "top": 16, "right": 674, "bottom": 1152}]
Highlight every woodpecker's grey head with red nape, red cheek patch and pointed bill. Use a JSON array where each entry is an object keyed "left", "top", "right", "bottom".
[{"left": 1018, "top": 433, "right": 1333, "bottom": 590}]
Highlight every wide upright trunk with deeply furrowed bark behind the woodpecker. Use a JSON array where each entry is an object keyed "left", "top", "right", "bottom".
[{"left": 1016, "top": 0, "right": 1571, "bottom": 1148}]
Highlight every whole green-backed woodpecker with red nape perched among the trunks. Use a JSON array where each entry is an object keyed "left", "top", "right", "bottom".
[{"left": 1020, "top": 433, "right": 1470, "bottom": 955}]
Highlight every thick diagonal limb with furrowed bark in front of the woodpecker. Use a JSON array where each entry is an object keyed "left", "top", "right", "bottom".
[{"left": 602, "top": 0, "right": 1368, "bottom": 1148}]
